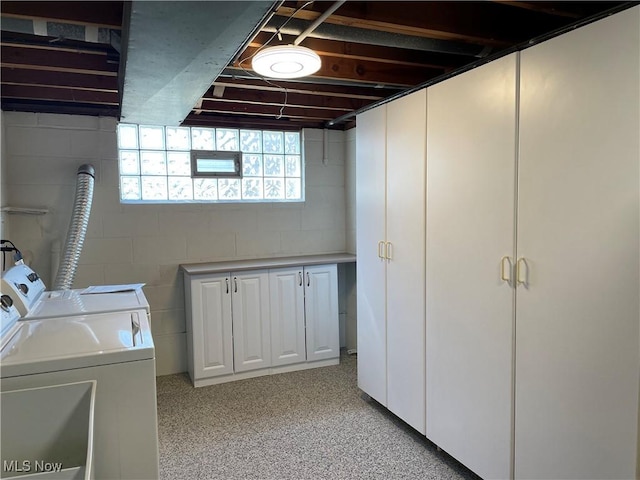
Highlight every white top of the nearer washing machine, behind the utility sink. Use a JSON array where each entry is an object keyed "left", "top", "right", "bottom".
[{"left": 0, "top": 310, "right": 155, "bottom": 378}]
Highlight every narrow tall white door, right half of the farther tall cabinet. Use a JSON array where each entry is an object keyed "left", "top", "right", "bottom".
[{"left": 384, "top": 89, "right": 427, "bottom": 434}]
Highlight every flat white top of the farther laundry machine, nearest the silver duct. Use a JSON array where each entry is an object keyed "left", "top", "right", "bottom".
[{"left": 25, "top": 288, "right": 150, "bottom": 320}]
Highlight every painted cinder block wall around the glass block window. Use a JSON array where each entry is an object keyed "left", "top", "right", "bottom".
[{"left": 2, "top": 112, "right": 355, "bottom": 375}]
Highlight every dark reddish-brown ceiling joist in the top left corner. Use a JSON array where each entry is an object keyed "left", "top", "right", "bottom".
[{"left": 0, "top": 0, "right": 124, "bottom": 30}]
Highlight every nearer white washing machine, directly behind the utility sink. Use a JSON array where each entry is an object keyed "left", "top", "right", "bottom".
[{"left": 0, "top": 304, "right": 158, "bottom": 480}]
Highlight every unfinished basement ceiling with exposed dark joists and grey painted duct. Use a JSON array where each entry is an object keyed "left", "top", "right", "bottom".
[{"left": 0, "top": 1, "right": 640, "bottom": 129}]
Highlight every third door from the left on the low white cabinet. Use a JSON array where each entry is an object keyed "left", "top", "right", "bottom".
[{"left": 269, "top": 267, "right": 306, "bottom": 366}]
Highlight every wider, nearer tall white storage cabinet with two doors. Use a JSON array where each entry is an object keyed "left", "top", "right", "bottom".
[{"left": 426, "top": 7, "right": 640, "bottom": 479}]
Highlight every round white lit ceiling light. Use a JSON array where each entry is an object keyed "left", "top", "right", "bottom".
[{"left": 251, "top": 45, "right": 322, "bottom": 78}]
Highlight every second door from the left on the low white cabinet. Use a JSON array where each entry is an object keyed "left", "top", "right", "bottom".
[{"left": 232, "top": 270, "right": 271, "bottom": 372}]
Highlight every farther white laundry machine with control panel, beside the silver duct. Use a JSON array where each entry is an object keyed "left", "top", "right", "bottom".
[{"left": 1, "top": 263, "right": 151, "bottom": 320}]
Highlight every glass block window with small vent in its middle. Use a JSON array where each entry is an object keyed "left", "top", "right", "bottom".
[{"left": 118, "top": 123, "right": 304, "bottom": 203}]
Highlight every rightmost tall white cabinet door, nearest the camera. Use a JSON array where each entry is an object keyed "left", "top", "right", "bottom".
[{"left": 515, "top": 7, "right": 640, "bottom": 479}]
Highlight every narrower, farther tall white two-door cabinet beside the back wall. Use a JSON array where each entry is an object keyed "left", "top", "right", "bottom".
[{"left": 356, "top": 90, "right": 427, "bottom": 434}]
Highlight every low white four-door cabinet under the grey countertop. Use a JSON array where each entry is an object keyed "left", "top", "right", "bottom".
[{"left": 182, "top": 257, "right": 351, "bottom": 387}]
